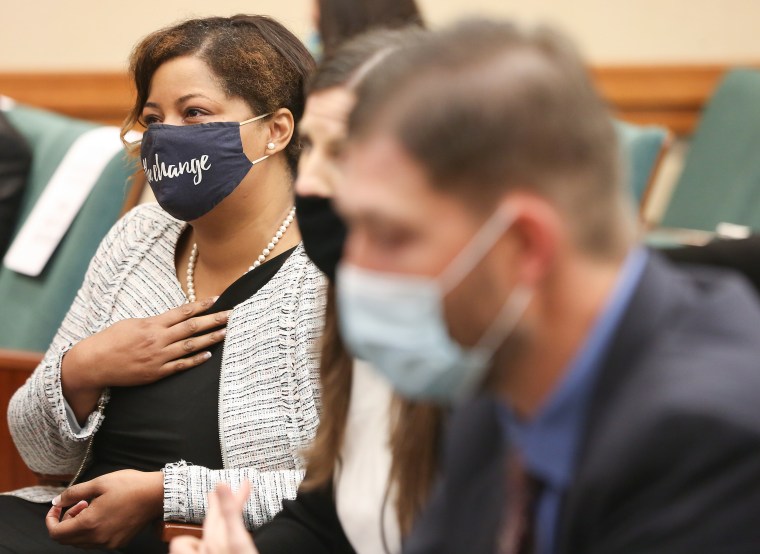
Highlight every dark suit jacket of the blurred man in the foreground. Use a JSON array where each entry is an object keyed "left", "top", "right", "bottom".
[{"left": 405, "top": 256, "right": 760, "bottom": 554}]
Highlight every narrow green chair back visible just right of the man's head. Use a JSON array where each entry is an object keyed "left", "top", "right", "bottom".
[{"left": 614, "top": 120, "right": 670, "bottom": 206}]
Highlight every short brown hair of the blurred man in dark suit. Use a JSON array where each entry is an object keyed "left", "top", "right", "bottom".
[{"left": 350, "top": 20, "right": 635, "bottom": 255}]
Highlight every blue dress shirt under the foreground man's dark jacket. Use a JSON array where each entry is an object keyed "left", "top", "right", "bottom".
[{"left": 502, "top": 248, "right": 647, "bottom": 554}]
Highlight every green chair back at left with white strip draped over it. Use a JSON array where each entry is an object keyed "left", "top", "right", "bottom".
[{"left": 0, "top": 105, "right": 135, "bottom": 351}]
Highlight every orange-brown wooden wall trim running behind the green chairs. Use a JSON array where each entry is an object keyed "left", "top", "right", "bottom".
[{"left": 0, "top": 63, "right": 760, "bottom": 135}]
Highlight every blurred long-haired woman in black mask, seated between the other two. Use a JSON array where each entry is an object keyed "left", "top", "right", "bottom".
[{"left": 172, "top": 29, "right": 442, "bottom": 554}]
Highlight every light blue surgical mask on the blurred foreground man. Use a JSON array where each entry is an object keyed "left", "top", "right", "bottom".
[{"left": 337, "top": 210, "right": 532, "bottom": 403}]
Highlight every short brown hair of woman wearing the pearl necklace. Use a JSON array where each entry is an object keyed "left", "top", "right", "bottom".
[{"left": 122, "top": 15, "right": 314, "bottom": 174}]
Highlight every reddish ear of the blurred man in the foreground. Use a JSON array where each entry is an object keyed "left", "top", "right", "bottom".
[{"left": 499, "top": 192, "right": 564, "bottom": 287}]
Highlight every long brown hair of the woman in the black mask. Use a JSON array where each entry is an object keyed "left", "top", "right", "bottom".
[{"left": 301, "top": 30, "right": 442, "bottom": 536}]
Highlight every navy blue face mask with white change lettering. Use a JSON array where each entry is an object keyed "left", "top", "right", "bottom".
[{"left": 140, "top": 114, "right": 270, "bottom": 221}]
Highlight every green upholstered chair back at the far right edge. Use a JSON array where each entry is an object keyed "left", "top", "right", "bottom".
[{"left": 661, "top": 69, "right": 760, "bottom": 231}]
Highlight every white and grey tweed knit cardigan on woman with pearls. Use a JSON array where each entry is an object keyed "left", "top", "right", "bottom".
[{"left": 8, "top": 204, "right": 326, "bottom": 528}]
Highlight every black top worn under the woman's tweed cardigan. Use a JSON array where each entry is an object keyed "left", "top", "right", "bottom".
[{"left": 80, "top": 248, "right": 294, "bottom": 481}]
